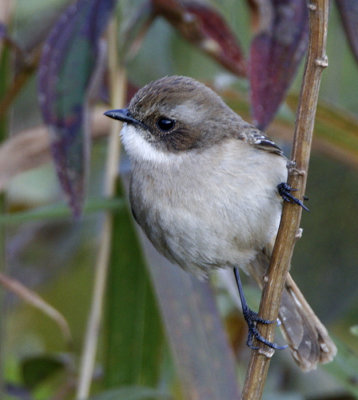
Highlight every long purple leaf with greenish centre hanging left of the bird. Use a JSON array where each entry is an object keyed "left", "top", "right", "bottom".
[{"left": 38, "top": 0, "right": 115, "bottom": 217}]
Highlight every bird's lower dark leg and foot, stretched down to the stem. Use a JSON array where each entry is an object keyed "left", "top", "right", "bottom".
[{"left": 234, "top": 267, "right": 287, "bottom": 350}]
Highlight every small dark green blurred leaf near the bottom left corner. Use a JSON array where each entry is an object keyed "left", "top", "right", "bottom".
[{"left": 21, "top": 356, "right": 64, "bottom": 389}]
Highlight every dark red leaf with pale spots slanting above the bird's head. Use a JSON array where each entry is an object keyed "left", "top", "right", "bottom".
[{"left": 151, "top": 0, "right": 246, "bottom": 76}]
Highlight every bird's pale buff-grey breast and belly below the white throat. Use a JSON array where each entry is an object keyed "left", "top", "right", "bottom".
[{"left": 131, "top": 140, "right": 287, "bottom": 275}]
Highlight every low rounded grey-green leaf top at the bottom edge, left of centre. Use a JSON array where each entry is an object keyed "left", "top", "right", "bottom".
[{"left": 88, "top": 386, "right": 170, "bottom": 400}]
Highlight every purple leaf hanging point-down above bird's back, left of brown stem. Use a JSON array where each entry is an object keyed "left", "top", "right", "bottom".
[{"left": 249, "top": 0, "right": 308, "bottom": 129}]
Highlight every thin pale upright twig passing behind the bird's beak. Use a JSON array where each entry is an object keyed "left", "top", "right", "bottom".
[{"left": 77, "top": 20, "right": 126, "bottom": 400}]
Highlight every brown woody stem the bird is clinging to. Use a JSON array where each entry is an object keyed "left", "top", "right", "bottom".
[{"left": 243, "top": 0, "right": 329, "bottom": 400}]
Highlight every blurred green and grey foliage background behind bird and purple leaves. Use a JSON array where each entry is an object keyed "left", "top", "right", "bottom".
[{"left": 0, "top": 0, "right": 358, "bottom": 400}]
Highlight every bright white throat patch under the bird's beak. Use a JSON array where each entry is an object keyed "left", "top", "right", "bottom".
[{"left": 120, "top": 123, "right": 182, "bottom": 163}]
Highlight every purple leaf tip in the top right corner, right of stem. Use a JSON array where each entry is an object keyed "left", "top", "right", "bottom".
[{"left": 336, "top": 0, "right": 358, "bottom": 62}]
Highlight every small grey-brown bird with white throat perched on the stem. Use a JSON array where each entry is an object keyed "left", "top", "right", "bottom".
[{"left": 105, "top": 76, "right": 336, "bottom": 371}]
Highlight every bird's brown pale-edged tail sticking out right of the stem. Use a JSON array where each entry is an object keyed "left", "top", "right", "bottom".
[{"left": 250, "top": 255, "right": 337, "bottom": 371}]
